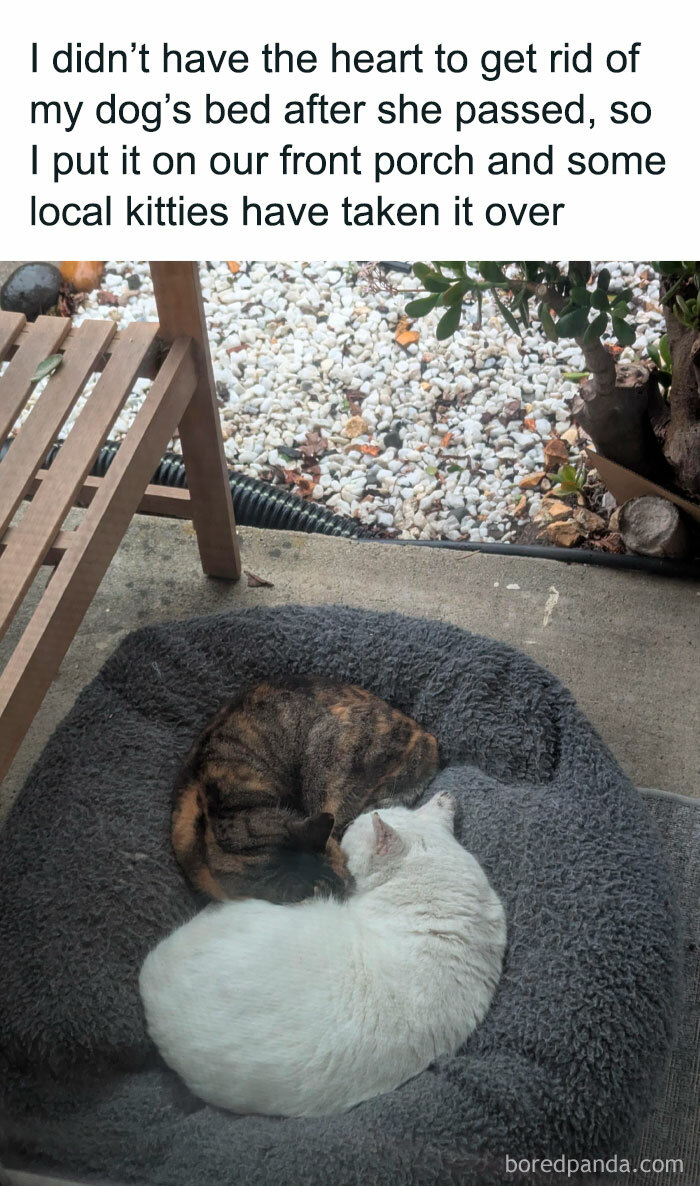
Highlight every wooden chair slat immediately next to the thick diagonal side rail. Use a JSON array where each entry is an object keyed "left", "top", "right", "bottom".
[{"left": 0, "top": 321, "right": 160, "bottom": 638}]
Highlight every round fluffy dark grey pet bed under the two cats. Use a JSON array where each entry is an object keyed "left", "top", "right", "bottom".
[{"left": 0, "top": 606, "right": 679, "bottom": 1186}]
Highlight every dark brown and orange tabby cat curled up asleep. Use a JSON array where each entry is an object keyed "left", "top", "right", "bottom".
[{"left": 172, "top": 678, "right": 438, "bottom": 903}]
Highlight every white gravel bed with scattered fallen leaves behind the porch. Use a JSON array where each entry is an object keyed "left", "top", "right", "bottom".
[{"left": 61, "top": 262, "right": 663, "bottom": 541}]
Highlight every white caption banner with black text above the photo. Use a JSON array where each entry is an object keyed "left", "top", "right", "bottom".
[{"left": 0, "top": 0, "right": 699, "bottom": 259}]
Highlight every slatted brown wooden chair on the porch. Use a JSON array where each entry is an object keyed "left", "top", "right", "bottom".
[{"left": 0, "top": 263, "right": 241, "bottom": 780}]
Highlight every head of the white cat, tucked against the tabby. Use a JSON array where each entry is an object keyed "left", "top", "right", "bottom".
[{"left": 341, "top": 791, "right": 454, "bottom": 891}]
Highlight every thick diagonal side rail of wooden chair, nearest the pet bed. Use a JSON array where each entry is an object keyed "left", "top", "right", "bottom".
[{"left": 0, "top": 338, "right": 197, "bottom": 779}]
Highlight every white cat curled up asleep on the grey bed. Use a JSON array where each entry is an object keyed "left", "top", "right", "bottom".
[{"left": 140, "top": 793, "right": 505, "bottom": 1116}]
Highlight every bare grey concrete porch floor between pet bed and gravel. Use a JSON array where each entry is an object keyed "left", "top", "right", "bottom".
[{"left": 0, "top": 516, "right": 700, "bottom": 818}]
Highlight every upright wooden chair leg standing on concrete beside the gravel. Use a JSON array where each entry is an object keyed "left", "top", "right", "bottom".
[{"left": 151, "top": 262, "right": 241, "bottom": 580}]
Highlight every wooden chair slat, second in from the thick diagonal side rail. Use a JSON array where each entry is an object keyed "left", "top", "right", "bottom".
[{"left": 0, "top": 321, "right": 114, "bottom": 536}]
